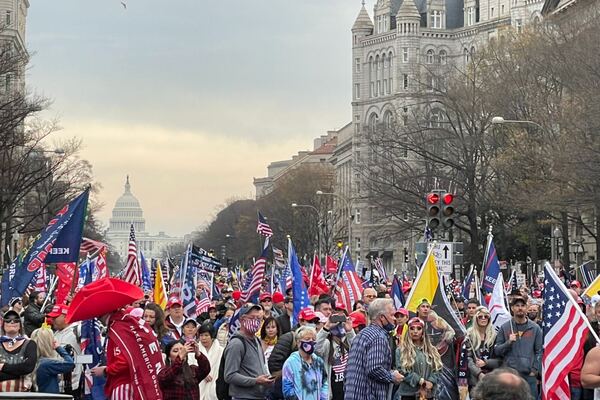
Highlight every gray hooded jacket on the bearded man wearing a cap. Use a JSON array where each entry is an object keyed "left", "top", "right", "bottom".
[{"left": 223, "top": 335, "right": 268, "bottom": 399}]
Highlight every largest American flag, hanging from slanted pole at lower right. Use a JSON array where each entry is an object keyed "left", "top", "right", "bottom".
[{"left": 542, "top": 263, "right": 598, "bottom": 400}]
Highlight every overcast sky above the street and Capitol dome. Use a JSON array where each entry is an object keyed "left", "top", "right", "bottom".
[{"left": 26, "top": 0, "right": 373, "bottom": 235}]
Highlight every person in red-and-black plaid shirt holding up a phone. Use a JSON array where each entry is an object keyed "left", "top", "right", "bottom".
[{"left": 158, "top": 340, "right": 210, "bottom": 400}]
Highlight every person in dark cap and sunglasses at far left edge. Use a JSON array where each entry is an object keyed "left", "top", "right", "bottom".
[{"left": 0, "top": 310, "right": 37, "bottom": 392}]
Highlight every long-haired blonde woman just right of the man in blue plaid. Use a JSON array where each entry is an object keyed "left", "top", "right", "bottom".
[{"left": 394, "top": 317, "right": 442, "bottom": 400}]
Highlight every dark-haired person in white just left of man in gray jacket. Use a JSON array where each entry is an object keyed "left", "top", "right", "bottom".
[{"left": 198, "top": 322, "right": 224, "bottom": 400}]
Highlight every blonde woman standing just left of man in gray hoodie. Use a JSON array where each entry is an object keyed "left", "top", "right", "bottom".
[{"left": 465, "top": 307, "right": 501, "bottom": 388}]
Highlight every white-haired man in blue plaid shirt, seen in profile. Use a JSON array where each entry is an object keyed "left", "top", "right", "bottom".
[{"left": 344, "top": 299, "right": 404, "bottom": 400}]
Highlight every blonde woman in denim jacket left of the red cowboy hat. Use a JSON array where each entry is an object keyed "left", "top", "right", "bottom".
[{"left": 31, "top": 328, "right": 75, "bottom": 393}]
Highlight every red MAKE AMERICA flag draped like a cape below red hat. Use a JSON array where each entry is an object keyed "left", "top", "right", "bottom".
[{"left": 108, "top": 310, "right": 165, "bottom": 400}]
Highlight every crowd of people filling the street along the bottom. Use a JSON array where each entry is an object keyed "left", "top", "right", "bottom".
[{"left": 0, "top": 282, "right": 600, "bottom": 400}]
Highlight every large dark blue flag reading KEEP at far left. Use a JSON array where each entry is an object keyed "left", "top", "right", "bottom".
[{"left": 10, "top": 190, "right": 89, "bottom": 296}]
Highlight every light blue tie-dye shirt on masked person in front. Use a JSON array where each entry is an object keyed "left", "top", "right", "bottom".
[{"left": 282, "top": 351, "right": 329, "bottom": 400}]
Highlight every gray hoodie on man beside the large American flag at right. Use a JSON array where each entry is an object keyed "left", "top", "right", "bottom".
[{"left": 494, "top": 319, "right": 543, "bottom": 376}]
